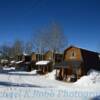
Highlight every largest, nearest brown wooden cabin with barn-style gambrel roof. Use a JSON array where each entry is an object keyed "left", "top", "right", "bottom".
[{"left": 55, "top": 46, "right": 100, "bottom": 81}]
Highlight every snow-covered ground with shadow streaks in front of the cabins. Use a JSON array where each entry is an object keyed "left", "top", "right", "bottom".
[{"left": 0, "top": 68, "right": 100, "bottom": 100}]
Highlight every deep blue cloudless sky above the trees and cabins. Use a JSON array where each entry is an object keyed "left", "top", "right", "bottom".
[{"left": 0, "top": 0, "right": 100, "bottom": 51}]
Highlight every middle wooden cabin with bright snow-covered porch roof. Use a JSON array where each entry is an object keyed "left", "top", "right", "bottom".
[{"left": 36, "top": 51, "right": 62, "bottom": 74}]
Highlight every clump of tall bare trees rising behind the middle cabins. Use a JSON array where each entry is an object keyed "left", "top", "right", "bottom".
[{"left": 33, "top": 23, "right": 68, "bottom": 61}]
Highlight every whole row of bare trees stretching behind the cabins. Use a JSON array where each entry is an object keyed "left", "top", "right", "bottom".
[{"left": 0, "top": 22, "right": 68, "bottom": 57}]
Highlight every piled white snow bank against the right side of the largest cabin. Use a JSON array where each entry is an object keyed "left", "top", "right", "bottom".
[{"left": 74, "top": 70, "right": 100, "bottom": 86}]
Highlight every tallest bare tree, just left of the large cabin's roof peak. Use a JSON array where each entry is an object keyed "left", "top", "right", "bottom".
[{"left": 48, "top": 23, "right": 68, "bottom": 52}]
